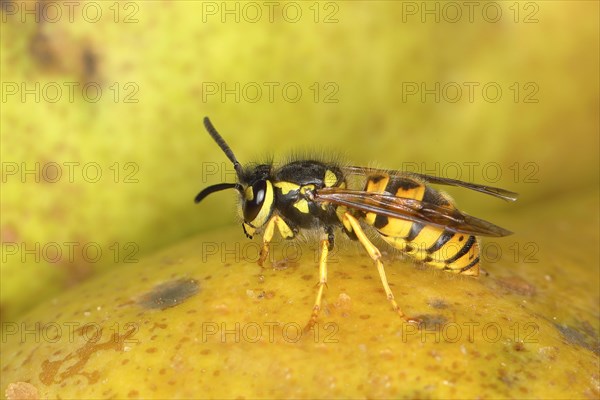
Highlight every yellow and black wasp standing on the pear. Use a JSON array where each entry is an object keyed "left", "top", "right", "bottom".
[{"left": 195, "top": 117, "right": 517, "bottom": 330}]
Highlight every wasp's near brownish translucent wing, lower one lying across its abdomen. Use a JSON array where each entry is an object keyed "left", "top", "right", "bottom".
[{"left": 313, "top": 187, "right": 512, "bottom": 237}]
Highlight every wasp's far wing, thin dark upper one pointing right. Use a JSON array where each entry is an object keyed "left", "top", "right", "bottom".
[{"left": 342, "top": 167, "right": 519, "bottom": 201}]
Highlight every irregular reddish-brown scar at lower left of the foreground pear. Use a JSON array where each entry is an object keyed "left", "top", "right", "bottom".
[{"left": 39, "top": 328, "right": 137, "bottom": 386}]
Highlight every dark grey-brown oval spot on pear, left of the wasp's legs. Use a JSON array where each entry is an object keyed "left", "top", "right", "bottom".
[{"left": 137, "top": 279, "right": 200, "bottom": 310}]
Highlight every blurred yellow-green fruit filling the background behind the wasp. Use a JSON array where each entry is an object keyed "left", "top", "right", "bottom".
[{"left": 0, "top": 0, "right": 599, "bottom": 321}]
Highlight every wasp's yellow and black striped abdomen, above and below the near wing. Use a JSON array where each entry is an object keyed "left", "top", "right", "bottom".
[{"left": 365, "top": 174, "right": 479, "bottom": 276}]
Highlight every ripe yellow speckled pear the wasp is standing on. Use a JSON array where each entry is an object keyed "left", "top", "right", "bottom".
[{"left": 1, "top": 189, "right": 599, "bottom": 399}]
